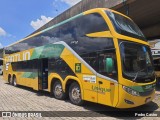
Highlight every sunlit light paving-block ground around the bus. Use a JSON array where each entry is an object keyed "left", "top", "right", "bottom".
[{"left": 0, "top": 77, "right": 160, "bottom": 120}]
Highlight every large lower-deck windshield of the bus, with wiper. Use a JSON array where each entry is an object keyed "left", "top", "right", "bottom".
[{"left": 120, "top": 42, "right": 155, "bottom": 83}]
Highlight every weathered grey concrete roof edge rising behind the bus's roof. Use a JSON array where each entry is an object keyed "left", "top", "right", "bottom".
[{"left": 32, "top": 0, "right": 125, "bottom": 34}]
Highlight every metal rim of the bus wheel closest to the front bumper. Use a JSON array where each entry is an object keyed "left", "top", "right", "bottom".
[{"left": 72, "top": 87, "right": 81, "bottom": 102}]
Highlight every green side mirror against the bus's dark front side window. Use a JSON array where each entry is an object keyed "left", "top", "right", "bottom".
[{"left": 105, "top": 58, "right": 114, "bottom": 73}]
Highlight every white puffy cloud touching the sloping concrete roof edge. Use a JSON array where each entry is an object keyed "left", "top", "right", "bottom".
[{"left": 30, "top": 15, "right": 53, "bottom": 30}]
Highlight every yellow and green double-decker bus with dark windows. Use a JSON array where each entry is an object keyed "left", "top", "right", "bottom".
[{"left": 4, "top": 8, "right": 156, "bottom": 108}]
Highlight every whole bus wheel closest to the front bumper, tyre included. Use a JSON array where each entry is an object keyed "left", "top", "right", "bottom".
[{"left": 69, "top": 82, "right": 83, "bottom": 105}]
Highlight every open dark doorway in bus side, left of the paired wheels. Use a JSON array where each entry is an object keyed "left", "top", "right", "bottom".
[{"left": 38, "top": 59, "right": 48, "bottom": 90}]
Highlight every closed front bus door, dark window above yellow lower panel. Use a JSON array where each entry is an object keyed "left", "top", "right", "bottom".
[{"left": 97, "top": 50, "right": 118, "bottom": 107}]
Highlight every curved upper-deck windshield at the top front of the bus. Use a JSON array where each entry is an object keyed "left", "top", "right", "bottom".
[{"left": 106, "top": 11, "right": 146, "bottom": 41}]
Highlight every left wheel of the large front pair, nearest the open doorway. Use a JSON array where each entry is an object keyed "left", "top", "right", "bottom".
[{"left": 52, "top": 81, "right": 66, "bottom": 100}]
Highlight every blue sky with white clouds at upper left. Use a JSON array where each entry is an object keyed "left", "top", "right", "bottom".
[{"left": 0, "top": 0, "right": 81, "bottom": 48}]
